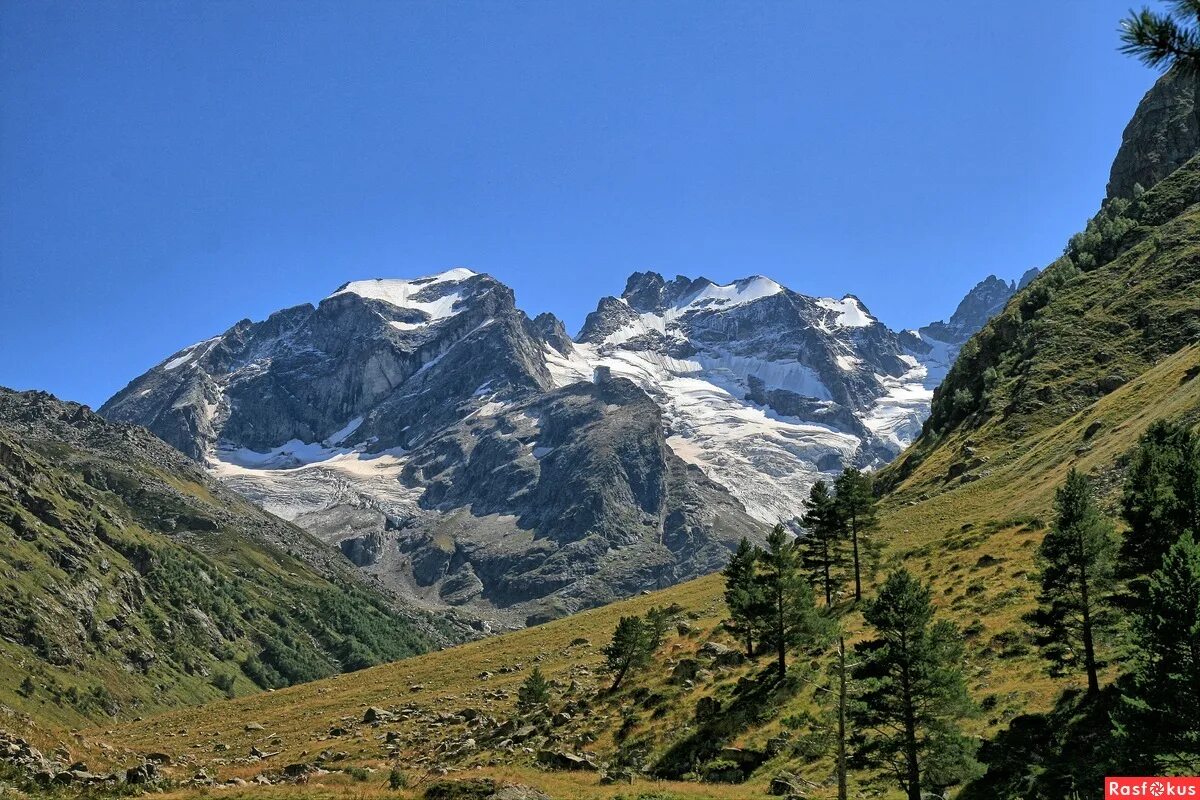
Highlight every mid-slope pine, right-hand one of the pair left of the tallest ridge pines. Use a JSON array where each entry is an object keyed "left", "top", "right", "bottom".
[{"left": 757, "top": 525, "right": 824, "bottom": 679}]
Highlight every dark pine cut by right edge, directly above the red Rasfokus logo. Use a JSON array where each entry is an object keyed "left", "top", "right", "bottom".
[{"left": 1116, "top": 533, "right": 1200, "bottom": 774}]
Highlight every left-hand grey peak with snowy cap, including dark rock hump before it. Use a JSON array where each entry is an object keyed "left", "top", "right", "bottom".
[{"left": 101, "top": 270, "right": 758, "bottom": 624}]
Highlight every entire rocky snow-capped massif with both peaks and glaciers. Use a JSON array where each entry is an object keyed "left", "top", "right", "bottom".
[{"left": 101, "top": 269, "right": 1017, "bottom": 625}]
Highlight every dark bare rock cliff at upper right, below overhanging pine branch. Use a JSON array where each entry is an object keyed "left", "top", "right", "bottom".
[{"left": 1108, "top": 71, "right": 1200, "bottom": 198}]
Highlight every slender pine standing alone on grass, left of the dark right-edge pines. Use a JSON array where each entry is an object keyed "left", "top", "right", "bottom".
[{"left": 1030, "top": 469, "right": 1114, "bottom": 693}]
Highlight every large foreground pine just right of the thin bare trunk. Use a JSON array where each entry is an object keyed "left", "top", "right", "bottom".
[{"left": 851, "top": 570, "right": 979, "bottom": 800}]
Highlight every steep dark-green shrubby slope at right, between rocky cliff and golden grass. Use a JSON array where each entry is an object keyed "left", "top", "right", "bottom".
[{"left": 882, "top": 156, "right": 1200, "bottom": 497}]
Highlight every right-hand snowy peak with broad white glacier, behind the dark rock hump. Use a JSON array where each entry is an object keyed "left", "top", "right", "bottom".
[{"left": 551, "top": 272, "right": 932, "bottom": 523}]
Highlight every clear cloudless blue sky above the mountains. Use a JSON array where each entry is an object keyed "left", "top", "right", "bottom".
[{"left": 0, "top": 0, "right": 1156, "bottom": 405}]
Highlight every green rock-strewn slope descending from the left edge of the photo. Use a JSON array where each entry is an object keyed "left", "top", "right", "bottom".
[{"left": 0, "top": 389, "right": 449, "bottom": 724}]
